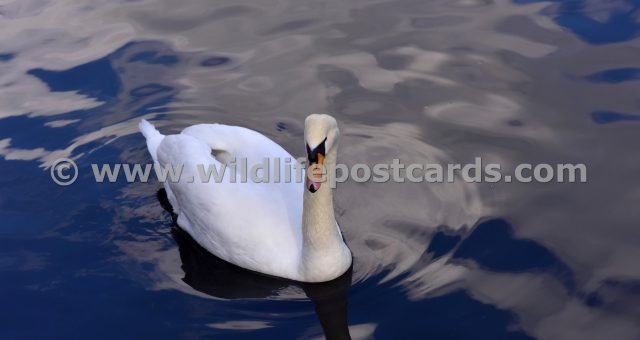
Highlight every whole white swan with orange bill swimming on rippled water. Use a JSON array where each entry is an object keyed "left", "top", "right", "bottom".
[{"left": 139, "top": 114, "right": 352, "bottom": 282}]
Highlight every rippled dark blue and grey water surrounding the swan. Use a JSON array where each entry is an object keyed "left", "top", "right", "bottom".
[{"left": 0, "top": 0, "right": 640, "bottom": 340}]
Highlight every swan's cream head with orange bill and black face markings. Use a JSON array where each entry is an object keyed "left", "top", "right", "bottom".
[{"left": 304, "top": 114, "right": 340, "bottom": 193}]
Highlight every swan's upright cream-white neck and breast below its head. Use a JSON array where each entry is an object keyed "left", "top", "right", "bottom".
[{"left": 302, "top": 148, "right": 351, "bottom": 281}]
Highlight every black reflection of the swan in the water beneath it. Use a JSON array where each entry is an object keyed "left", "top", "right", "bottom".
[{"left": 157, "top": 189, "right": 352, "bottom": 339}]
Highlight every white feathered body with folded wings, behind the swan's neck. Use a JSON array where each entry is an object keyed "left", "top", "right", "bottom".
[{"left": 158, "top": 125, "right": 303, "bottom": 274}]
